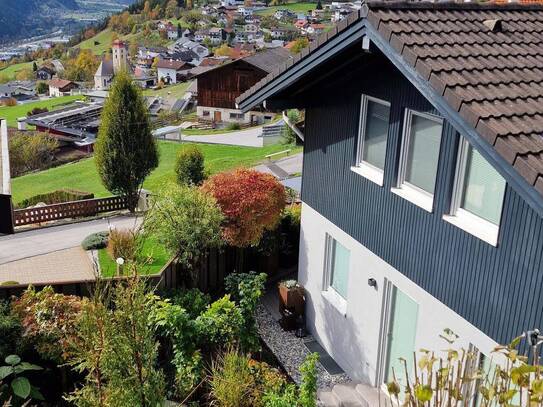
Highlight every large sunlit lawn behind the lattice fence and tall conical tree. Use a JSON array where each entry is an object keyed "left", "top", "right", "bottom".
[{"left": 12, "top": 141, "right": 301, "bottom": 202}]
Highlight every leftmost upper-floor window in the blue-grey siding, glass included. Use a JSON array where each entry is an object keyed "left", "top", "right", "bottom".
[{"left": 353, "top": 95, "right": 390, "bottom": 185}]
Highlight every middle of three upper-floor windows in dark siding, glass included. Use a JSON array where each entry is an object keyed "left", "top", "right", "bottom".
[{"left": 393, "top": 110, "right": 443, "bottom": 212}]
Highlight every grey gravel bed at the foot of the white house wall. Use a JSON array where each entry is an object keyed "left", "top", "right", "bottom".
[{"left": 257, "top": 305, "right": 351, "bottom": 390}]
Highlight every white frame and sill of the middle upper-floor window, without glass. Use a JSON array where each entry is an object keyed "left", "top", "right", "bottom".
[{"left": 391, "top": 109, "right": 443, "bottom": 212}]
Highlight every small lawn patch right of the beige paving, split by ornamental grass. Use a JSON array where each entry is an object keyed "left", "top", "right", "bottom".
[{"left": 98, "top": 239, "right": 171, "bottom": 277}]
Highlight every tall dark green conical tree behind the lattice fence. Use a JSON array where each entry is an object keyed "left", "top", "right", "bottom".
[{"left": 95, "top": 72, "right": 158, "bottom": 211}]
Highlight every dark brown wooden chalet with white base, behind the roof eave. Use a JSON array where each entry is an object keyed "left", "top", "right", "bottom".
[{"left": 196, "top": 48, "right": 292, "bottom": 124}]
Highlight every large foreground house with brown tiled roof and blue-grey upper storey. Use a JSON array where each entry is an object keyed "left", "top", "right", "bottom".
[{"left": 236, "top": 2, "right": 543, "bottom": 406}]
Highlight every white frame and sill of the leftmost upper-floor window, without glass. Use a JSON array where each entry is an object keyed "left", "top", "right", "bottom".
[{"left": 351, "top": 94, "right": 391, "bottom": 187}]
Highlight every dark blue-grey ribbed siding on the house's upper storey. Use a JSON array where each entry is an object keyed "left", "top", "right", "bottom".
[{"left": 302, "top": 59, "right": 543, "bottom": 343}]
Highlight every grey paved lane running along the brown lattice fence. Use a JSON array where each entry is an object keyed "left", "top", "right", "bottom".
[{"left": 0, "top": 215, "right": 141, "bottom": 266}]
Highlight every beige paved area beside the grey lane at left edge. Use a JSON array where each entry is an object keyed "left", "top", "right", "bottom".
[{"left": 0, "top": 247, "right": 95, "bottom": 284}]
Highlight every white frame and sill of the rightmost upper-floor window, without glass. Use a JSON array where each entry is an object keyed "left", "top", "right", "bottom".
[{"left": 443, "top": 137, "right": 505, "bottom": 246}]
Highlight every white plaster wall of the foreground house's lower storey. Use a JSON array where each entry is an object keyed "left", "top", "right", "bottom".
[{"left": 298, "top": 203, "right": 496, "bottom": 386}]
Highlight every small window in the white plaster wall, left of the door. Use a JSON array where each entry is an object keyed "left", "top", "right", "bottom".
[{"left": 324, "top": 235, "right": 351, "bottom": 299}]
